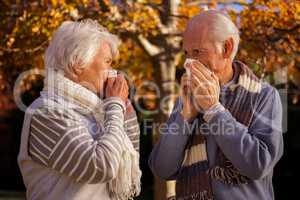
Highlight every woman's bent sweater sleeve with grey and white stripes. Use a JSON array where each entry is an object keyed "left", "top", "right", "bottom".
[{"left": 29, "top": 98, "right": 125, "bottom": 183}]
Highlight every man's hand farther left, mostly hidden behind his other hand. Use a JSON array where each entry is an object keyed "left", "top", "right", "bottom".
[{"left": 180, "top": 73, "right": 198, "bottom": 120}]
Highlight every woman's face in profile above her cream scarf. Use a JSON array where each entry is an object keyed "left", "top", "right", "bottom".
[{"left": 78, "top": 42, "right": 113, "bottom": 97}]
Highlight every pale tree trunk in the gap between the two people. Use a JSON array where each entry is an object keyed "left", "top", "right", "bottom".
[{"left": 153, "top": 0, "right": 180, "bottom": 200}]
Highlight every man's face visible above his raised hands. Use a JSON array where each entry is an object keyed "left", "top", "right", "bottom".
[{"left": 183, "top": 25, "right": 225, "bottom": 78}]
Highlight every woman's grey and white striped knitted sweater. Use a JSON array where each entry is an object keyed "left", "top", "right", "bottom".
[{"left": 18, "top": 71, "right": 140, "bottom": 200}]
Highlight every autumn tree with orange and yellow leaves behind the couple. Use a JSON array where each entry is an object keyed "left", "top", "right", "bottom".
[{"left": 0, "top": 0, "right": 300, "bottom": 200}]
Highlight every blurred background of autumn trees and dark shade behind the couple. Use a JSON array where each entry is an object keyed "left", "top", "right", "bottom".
[{"left": 0, "top": 0, "right": 300, "bottom": 200}]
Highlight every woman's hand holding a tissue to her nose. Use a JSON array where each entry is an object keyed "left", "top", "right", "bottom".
[{"left": 105, "top": 74, "right": 128, "bottom": 102}]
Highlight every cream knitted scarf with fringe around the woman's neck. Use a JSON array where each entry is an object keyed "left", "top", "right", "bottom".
[{"left": 42, "top": 70, "right": 141, "bottom": 200}]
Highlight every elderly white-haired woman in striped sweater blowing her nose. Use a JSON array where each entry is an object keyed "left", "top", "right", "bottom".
[{"left": 18, "top": 20, "right": 141, "bottom": 200}]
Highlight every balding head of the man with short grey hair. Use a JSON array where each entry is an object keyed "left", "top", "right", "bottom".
[{"left": 182, "top": 10, "right": 239, "bottom": 83}]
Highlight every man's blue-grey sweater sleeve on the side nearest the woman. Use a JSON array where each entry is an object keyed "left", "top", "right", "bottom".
[{"left": 148, "top": 99, "right": 193, "bottom": 180}]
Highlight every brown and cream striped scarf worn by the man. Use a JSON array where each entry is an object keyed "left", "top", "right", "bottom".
[{"left": 176, "top": 61, "right": 261, "bottom": 200}]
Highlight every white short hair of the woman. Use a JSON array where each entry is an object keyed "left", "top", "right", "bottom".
[{"left": 45, "top": 19, "right": 120, "bottom": 74}]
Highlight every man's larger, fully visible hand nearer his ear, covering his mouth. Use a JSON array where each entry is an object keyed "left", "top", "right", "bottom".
[{"left": 189, "top": 61, "right": 220, "bottom": 112}]
